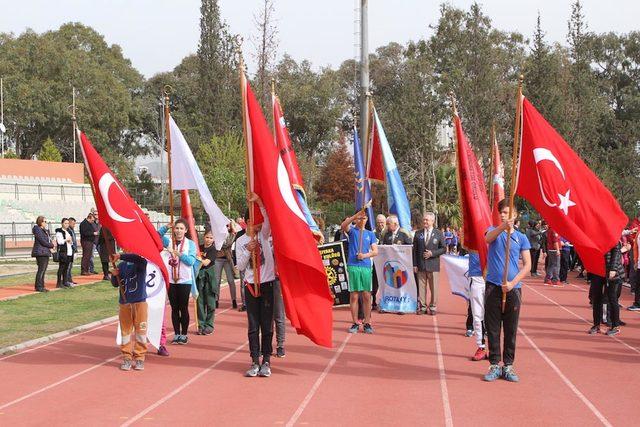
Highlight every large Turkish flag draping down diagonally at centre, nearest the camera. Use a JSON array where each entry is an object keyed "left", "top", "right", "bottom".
[{"left": 242, "top": 75, "right": 333, "bottom": 347}]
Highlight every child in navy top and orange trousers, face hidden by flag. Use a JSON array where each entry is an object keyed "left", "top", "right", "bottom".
[{"left": 111, "top": 254, "right": 148, "bottom": 371}]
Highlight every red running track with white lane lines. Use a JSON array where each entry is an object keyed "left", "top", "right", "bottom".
[{"left": 0, "top": 272, "right": 640, "bottom": 426}]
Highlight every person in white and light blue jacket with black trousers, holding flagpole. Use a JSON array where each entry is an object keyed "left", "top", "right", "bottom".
[{"left": 158, "top": 218, "right": 197, "bottom": 344}]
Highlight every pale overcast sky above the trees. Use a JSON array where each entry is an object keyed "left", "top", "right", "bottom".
[{"left": 0, "top": 0, "right": 640, "bottom": 77}]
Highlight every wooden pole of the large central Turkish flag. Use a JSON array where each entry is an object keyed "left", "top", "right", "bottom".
[{"left": 236, "top": 37, "right": 260, "bottom": 297}]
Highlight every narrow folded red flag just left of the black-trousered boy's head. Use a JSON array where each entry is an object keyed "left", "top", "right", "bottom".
[{"left": 453, "top": 114, "right": 491, "bottom": 271}]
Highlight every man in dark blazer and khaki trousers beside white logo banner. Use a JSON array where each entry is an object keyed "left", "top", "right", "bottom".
[{"left": 413, "top": 212, "right": 446, "bottom": 316}]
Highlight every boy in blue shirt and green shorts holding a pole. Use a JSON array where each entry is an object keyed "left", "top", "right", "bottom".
[{"left": 340, "top": 211, "right": 378, "bottom": 334}]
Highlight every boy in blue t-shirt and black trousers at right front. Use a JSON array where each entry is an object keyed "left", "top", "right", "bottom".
[{"left": 484, "top": 199, "right": 531, "bottom": 382}]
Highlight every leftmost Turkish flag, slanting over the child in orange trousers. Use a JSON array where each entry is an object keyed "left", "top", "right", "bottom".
[{"left": 78, "top": 131, "right": 170, "bottom": 286}]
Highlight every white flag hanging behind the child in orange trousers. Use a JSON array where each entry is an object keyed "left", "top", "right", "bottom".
[{"left": 116, "top": 260, "right": 167, "bottom": 348}]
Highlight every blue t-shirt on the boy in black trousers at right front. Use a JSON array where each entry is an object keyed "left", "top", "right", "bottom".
[{"left": 487, "top": 226, "right": 531, "bottom": 288}]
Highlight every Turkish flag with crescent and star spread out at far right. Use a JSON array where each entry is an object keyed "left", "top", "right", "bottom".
[{"left": 516, "top": 97, "right": 628, "bottom": 276}]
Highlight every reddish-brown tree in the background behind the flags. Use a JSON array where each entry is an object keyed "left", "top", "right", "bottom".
[{"left": 315, "top": 138, "right": 355, "bottom": 203}]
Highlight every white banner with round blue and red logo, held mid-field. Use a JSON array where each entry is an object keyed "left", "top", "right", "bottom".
[{"left": 373, "top": 245, "right": 418, "bottom": 313}]
